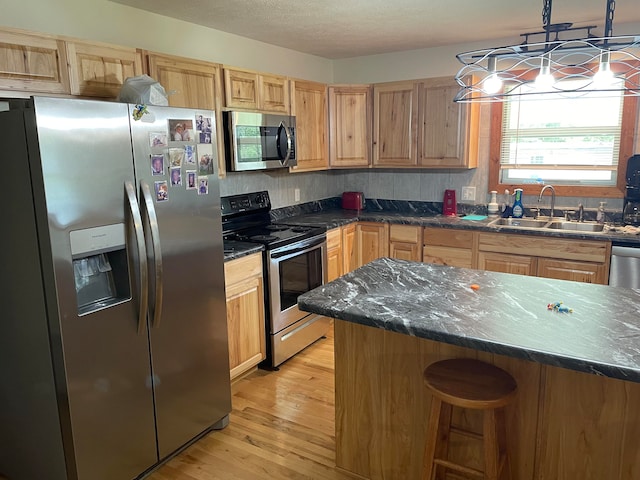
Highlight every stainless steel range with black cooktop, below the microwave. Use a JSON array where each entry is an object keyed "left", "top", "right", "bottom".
[{"left": 221, "top": 191, "right": 331, "bottom": 368}]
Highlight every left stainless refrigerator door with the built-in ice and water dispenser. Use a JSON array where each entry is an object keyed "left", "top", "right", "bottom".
[{"left": 29, "top": 98, "right": 158, "bottom": 480}]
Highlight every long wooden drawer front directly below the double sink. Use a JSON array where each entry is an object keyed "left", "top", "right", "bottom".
[{"left": 478, "top": 233, "right": 610, "bottom": 263}]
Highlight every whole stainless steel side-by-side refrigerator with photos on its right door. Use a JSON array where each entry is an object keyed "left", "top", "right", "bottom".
[{"left": 0, "top": 97, "right": 231, "bottom": 480}]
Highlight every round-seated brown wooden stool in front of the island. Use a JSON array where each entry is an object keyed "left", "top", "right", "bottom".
[{"left": 422, "top": 358, "right": 517, "bottom": 480}]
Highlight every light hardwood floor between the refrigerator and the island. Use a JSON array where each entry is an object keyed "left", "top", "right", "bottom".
[{"left": 145, "top": 326, "right": 357, "bottom": 480}]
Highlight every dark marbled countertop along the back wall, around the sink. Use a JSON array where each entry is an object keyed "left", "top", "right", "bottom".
[{"left": 278, "top": 209, "right": 640, "bottom": 247}]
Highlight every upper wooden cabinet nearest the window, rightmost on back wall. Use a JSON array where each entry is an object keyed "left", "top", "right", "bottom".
[{"left": 418, "top": 77, "right": 480, "bottom": 168}]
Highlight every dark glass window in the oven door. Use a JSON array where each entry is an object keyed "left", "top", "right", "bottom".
[{"left": 279, "top": 248, "right": 322, "bottom": 311}]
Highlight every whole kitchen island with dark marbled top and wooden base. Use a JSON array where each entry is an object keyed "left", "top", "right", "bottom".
[{"left": 298, "top": 258, "right": 640, "bottom": 480}]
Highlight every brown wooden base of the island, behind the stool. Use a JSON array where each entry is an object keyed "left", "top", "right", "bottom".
[{"left": 335, "top": 320, "right": 640, "bottom": 480}]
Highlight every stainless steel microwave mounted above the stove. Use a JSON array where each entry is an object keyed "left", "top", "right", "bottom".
[{"left": 223, "top": 112, "right": 298, "bottom": 172}]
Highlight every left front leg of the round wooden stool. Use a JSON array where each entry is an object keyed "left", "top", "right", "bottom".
[{"left": 422, "top": 397, "right": 451, "bottom": 480}]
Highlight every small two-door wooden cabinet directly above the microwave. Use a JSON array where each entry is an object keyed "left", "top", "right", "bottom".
[{"left": 224, "top": 66, "right": 291, "bottom": 114}]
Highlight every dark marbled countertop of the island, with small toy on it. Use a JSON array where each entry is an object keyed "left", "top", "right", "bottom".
[{"left": 298, "top": 258, "right": 640, "bottom": 382}]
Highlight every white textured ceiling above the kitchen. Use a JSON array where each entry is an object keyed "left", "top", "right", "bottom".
[{"left": 113, "top": 0, "right": 640, "bottom": 59}]
